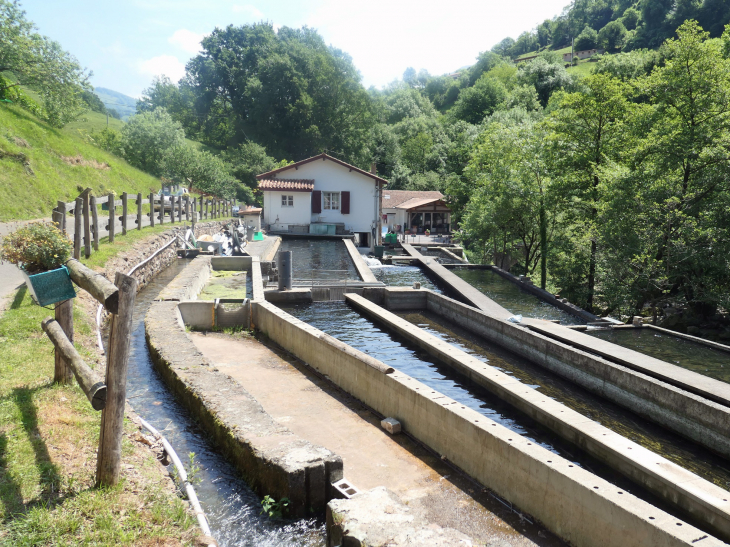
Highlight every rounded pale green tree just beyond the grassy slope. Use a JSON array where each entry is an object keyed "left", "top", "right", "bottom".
[{"left": 122, "top": 108, "right": 185, "bottom": 175}]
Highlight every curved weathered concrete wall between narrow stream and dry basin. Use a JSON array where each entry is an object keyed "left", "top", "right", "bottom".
[{"left": 145, "top": 302, "right": 343, "bottom": 516}]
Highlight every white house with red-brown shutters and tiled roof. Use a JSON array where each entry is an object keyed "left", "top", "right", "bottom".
[{"left": 256, "top": 154, "right": 388, "bottom": 247}]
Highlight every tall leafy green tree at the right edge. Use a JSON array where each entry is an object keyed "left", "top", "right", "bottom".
[{"left": 603, "top": 21, "right": 730, "bottom": 315}]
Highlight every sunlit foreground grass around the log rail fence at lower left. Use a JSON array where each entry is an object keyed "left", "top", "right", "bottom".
[{"left": 0, "top": 225, "right": 198, "bottom": 547}]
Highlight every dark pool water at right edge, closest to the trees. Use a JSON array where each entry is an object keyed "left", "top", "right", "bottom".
[{"left": 586, "top": 328, "right": 730, "bottom": 382}]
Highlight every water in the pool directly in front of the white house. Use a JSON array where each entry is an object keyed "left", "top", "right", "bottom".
[{"left": 279, "top": 238, "right": 360, "bottom": 285}]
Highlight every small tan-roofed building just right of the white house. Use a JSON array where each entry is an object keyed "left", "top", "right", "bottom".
[{"left": 381, "top": 189, "right": 451, "bottom": 234}]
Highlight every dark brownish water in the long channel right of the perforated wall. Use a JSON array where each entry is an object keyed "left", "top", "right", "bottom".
[{"left": 398, "top": 311, "right": 730, "bottom": 490}]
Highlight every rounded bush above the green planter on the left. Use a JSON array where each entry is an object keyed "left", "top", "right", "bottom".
[{"left": 0, "top": 222, "right": 73, "bottom": 275}]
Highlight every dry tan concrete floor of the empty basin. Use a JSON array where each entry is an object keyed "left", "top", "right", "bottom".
[{"left": 190, "top": 333, "right": 562, "bottom": 547}]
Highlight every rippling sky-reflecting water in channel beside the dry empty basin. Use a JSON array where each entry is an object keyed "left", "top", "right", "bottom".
[{"left": 282, "top": 302, "right": 730, "bottom": 518}]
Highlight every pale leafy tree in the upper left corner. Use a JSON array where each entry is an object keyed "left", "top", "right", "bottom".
[{"left": 0, "top": 0, "right": 91, "bottom": 127}]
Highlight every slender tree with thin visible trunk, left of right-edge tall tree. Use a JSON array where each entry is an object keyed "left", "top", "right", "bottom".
[{"left": 547, "top": 74, "right": 632, "bottom": 311}]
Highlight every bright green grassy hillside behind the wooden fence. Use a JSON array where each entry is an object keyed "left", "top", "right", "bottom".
[{"left": 0, "top": 104, "right": 160, "bottom": 222}]
